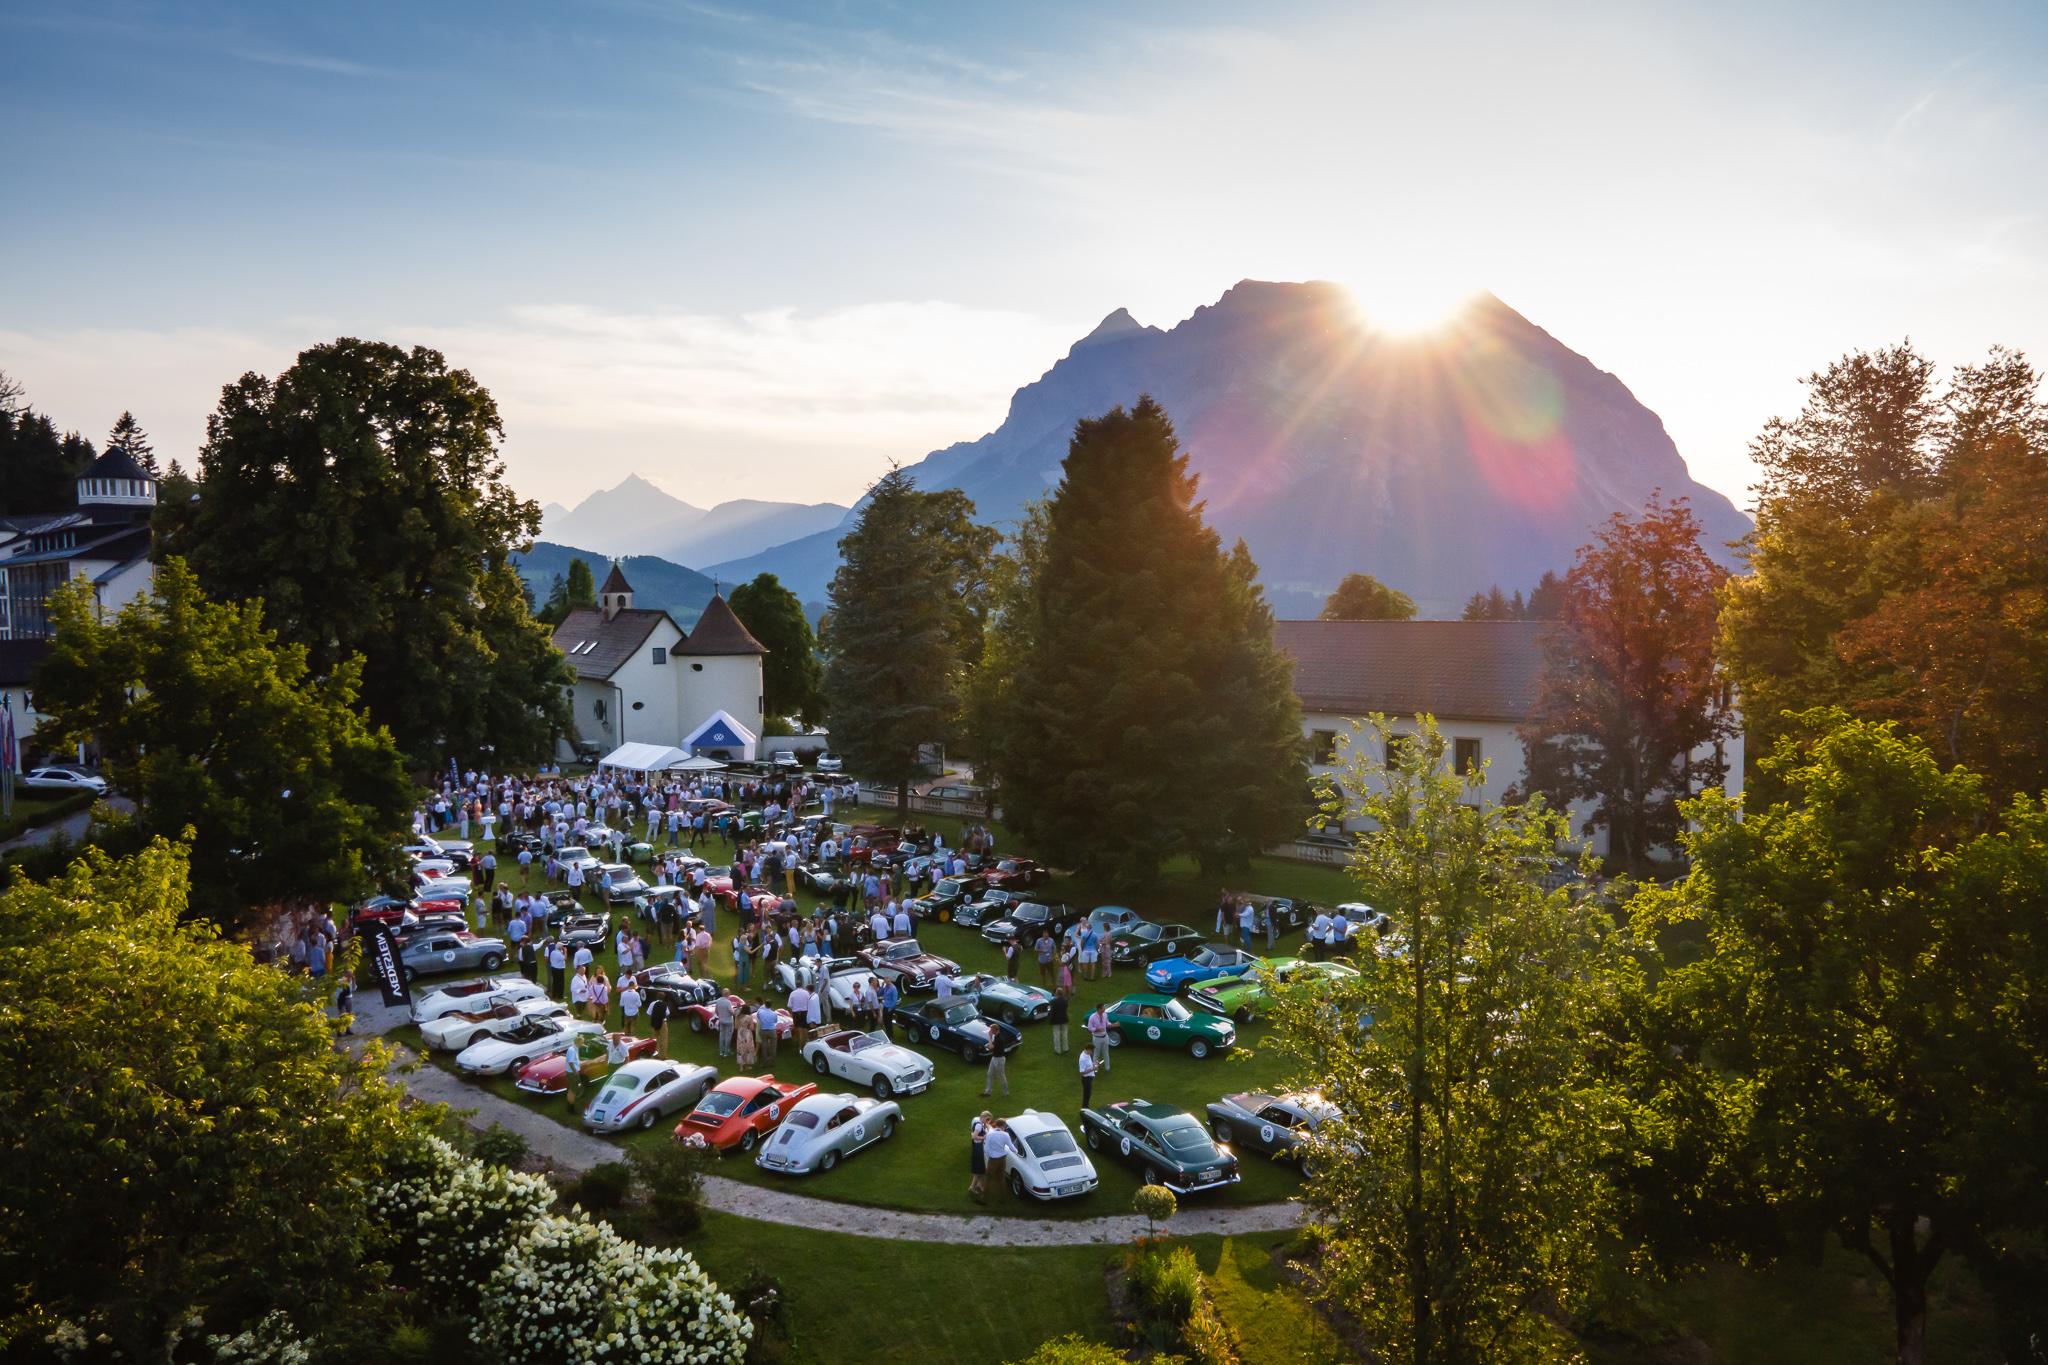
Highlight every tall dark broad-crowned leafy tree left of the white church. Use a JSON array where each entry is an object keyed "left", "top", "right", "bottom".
[{"left": 160, "top": 338, "right": 571, "bottom": 765}]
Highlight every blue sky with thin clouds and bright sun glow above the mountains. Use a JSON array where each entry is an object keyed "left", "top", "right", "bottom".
[{"left": 0, "top": 2, "right": 2048, "bottom": 505}]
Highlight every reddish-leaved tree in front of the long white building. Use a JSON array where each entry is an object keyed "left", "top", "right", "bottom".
[{"left": 1518, "top": 495, "right": 1737, "bottom": 872}]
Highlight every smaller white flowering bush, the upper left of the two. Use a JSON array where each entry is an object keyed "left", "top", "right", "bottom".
[{"left": 371, "top": 1138, "right": 555, "bottom": 1314}]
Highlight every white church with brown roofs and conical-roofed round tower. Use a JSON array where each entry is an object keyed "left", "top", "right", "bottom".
[{"left": 555, "top": 565, "right": 768, "bottom": 759}]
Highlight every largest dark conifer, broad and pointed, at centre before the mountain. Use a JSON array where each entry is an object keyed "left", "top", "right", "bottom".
[{"left": 995, "top": 397, "right": 1309, "bottom": 888}]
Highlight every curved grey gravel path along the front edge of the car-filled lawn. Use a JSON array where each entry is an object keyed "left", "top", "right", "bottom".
[{"left": 368, "top": 990, "right": 1303, "bottom": 1246}]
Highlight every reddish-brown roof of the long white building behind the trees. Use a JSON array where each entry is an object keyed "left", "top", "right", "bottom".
[{"left": 1274, "top": 620, "right": 1546, "bottom": 722}]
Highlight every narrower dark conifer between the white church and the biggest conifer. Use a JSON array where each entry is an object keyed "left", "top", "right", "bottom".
[{"left": 825, "top": 469, "right": 971, "bottom": 819}]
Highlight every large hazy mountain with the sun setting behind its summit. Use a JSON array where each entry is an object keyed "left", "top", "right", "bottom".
[{"left": 709, "top": 280, "right": 1749, "bottom": 616}]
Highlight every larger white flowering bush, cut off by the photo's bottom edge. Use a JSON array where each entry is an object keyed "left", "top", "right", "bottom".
[{"left": 475, "top": 1212, "right": 754, "bottom": 1365}]
